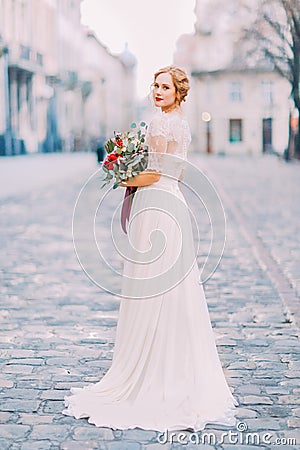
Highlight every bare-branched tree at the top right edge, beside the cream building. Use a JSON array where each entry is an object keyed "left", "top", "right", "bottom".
[{"left": 245, "top": 0, "right": 300, "bottom": 159}]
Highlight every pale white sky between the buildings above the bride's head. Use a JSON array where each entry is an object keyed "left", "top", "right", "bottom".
[{"left": 82, "top": 0, "right": 195, "bottom": 97}]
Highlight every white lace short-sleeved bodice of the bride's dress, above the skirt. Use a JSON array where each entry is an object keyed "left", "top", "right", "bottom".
[{"left": 146, "top": 111, "right": 191, "bottom": 178}]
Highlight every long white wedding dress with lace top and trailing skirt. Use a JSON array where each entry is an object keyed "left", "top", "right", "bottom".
[{"left": 63, "top": 111, "right": 238, "bottom": 431}]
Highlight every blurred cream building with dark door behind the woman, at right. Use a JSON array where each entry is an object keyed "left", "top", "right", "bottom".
[{"left": 174, "top": 0, "right": 290, "bottom": 154}]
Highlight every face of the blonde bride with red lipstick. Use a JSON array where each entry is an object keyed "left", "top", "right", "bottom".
[{"left": 153, "top": 73, "right": 176, "bottom": 111}]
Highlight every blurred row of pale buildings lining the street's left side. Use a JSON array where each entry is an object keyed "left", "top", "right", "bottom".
[{"left": 0, "top": 0, "right": 136, "bottom": 155}]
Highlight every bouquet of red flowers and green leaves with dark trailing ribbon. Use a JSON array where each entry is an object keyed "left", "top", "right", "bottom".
[{"left": 101, "top": 122, "right": 148, "bottom": 233}]
